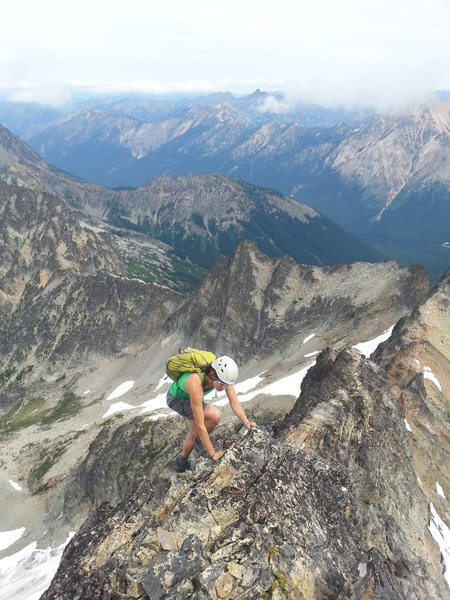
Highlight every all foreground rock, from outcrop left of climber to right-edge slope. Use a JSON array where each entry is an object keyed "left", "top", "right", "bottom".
[{"left": 34, "top": 274, "right": 450, "bottom": 600}]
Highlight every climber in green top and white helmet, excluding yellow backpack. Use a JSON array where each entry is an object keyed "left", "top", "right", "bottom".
[{"left": 167, "top": 356, "right": 256, "bottom": 473}]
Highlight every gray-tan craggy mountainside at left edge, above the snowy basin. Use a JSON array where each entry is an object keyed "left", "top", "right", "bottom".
[{"left": 0, "top": 183, "right": 181, "bottom": 398}]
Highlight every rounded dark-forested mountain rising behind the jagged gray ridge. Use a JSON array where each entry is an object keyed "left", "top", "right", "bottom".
[{"left": 93, "top": 175, "right": 383, "bottom": 266}]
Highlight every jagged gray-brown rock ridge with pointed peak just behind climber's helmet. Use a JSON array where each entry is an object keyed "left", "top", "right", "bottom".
[{"left": 168, "top": 242, "right": 428, "bottom": 368}]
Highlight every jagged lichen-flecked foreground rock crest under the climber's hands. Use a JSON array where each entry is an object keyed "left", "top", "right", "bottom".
[{"left": 43, "top": 340, "right": 448, "bottom": 600}]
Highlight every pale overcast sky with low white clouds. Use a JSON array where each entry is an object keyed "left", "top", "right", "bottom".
[{"left": 0, "top": 0, "right": 450, "bottom": 108}]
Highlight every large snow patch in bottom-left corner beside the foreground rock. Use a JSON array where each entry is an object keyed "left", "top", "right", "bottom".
[{"left": 0, "top": 532, "right": 75, "bottom": 600}]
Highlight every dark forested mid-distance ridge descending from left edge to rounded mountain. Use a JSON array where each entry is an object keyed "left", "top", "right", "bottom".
[{"left": 0, "top": 123, "right": 385, "bottom": 289}]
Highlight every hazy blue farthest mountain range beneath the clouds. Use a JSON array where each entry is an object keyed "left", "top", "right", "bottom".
[{"left": 0, "top": 91, "right": 450, "bottom": 277}]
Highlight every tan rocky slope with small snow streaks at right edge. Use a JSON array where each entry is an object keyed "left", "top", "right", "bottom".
[{"left": 375, "top": 271, "right": 450, "bottom": 560}]
